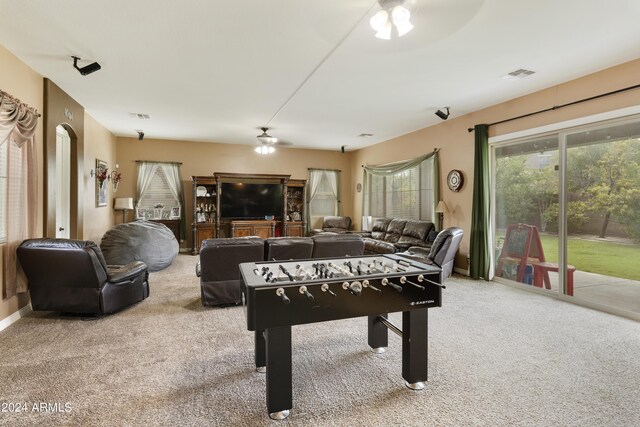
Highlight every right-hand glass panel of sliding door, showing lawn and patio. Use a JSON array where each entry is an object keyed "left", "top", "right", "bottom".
[{"left": 565, "top": 120, "right": 640, "bottom": 313}]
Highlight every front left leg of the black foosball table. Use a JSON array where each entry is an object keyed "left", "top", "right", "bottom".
[{"left": 265, "top": 326, "right": 293, "bottom": 420}]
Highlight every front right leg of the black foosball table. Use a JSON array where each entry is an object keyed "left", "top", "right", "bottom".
[{"left": 402, "top": 308, "right": 428, "bottom": 390}]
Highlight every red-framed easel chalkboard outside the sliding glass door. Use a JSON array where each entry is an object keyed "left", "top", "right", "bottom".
[{"left": 496, "top": 224, "right": 549, "bottom": 283}]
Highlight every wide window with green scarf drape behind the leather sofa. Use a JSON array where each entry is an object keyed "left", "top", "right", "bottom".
[{"left": 364, "top": 158, "right": 435, "bottom": 221}]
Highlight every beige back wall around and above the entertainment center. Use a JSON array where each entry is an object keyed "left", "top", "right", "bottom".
[{"left": 117, "top": 137, "right": 353, "bottom": 248}]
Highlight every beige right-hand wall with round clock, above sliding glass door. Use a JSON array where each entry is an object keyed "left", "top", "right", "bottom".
[{"left": 351, "top": 60, "right": 640, "bottom": 270}]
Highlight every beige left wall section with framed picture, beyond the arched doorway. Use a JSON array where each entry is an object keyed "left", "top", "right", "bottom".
[{"left": 83, "top": 111, "right": 117, "bottom": 244}]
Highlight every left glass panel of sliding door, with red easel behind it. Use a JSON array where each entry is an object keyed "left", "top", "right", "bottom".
[{"left": 493, "top": 135, "right": 559, "bottom": 292}]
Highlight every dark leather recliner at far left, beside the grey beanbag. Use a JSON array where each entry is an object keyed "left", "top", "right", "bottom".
[{"left": 17, "top": 238, "right": 149, "bottom": 314}]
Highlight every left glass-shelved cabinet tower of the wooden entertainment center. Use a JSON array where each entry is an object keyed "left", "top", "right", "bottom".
[{"left": 191, "top": 176, "right": 219, "bottom": 255}]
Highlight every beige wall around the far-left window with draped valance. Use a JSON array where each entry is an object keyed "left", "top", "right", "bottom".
[{"left": 0, "top": 46, "right": 44, "bottom": 320}]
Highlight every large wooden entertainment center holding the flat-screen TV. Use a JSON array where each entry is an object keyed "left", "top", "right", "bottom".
[{"left": 191, "top": 172, "right": 307, "bottom": 255}]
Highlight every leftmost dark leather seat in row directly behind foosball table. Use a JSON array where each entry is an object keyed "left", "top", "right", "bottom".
[{"left": 196, "top": 237, "right": 264, "bottom": 306}]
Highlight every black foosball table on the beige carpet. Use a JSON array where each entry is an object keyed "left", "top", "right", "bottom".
[{"left": 240, "top": 254, "right": 444, "bottom": 419}]
